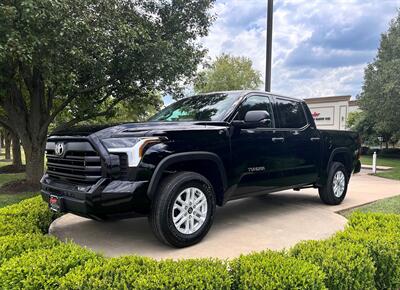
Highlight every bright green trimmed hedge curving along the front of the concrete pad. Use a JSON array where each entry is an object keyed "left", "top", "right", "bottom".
[{"left": 0, "top": 197, "right": 400, "bottom": 289}]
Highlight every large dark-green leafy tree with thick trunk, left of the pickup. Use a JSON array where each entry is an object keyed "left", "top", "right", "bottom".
[{"left": 0, "top": 0, "right": 213, "bottom": 184}]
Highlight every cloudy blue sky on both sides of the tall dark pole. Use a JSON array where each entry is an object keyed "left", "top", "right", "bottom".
[{"left": 201, "top": 0, "right": 400, "bottom": 98}]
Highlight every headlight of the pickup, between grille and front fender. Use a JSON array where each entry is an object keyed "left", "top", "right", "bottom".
[{"left": 102, "top": 137, "right": 160, "bottom": 167}]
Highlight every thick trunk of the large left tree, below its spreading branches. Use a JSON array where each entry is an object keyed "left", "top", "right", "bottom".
[{"left": 23, "top": 138, "right": 46, "bottom": 186}]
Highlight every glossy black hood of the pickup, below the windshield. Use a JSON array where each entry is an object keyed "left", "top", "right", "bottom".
[{"left": 50, "top": 122, "right": 228, "bottom": 139}]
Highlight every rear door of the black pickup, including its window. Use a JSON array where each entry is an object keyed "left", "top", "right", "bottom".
[{"left": 275, "top": 97, "right": 321, "bottom": 186}]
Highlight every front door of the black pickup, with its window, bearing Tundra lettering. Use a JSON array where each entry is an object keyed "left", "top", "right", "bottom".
[{"left": 231, "top": 95, "right": 284, "bottom": 198}]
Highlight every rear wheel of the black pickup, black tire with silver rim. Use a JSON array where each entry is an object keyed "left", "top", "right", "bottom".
[{"left": 318, "top": 162, "right": 349, "bottom": 205}]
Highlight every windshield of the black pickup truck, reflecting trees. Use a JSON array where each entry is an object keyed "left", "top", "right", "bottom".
[{"left": 149, "top": 93, "right": 239, "bottom": 122}]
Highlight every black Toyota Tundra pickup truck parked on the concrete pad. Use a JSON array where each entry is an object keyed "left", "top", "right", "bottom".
[{"left": 41, "top": 91, "right": 361, "bottom": 247}]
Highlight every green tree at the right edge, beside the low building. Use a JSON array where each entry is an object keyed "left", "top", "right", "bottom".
[{"left": 359, "top": 11, "right": 400, "bottom": 147}]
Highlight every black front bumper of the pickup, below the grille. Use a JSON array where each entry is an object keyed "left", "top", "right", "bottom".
[{"left": 41, "top": 174, "right": 150, "bottom": 219}]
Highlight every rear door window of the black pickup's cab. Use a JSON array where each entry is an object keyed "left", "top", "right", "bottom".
[{"left": 276, "top": 98, "right": 307, "bottom": 128}]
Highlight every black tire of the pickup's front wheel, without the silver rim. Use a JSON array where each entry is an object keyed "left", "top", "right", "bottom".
[{"left": 152, "top": 172, "right": 215, "bottom": 247}]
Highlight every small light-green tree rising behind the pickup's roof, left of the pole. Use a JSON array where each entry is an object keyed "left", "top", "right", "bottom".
[{"left": 194, "top": 54, "right": 262, "bottom": 93}]
